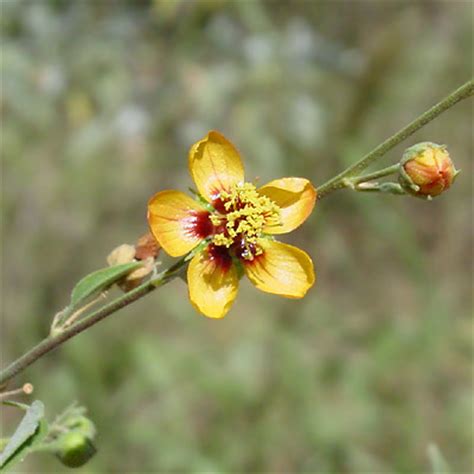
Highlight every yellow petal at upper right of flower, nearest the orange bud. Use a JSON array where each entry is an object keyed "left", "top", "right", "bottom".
[{"left": 258, "top": 178, "right": 316, "bottom": 234}]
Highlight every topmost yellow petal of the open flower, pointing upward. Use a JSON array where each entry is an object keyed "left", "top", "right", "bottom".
[{"left": 189, "top": 130, "right": 244, "bottom": 202}]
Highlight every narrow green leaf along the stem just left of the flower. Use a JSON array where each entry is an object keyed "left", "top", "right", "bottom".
[{"left": 71, "top": 262, "right": 142, "bottom": 308}]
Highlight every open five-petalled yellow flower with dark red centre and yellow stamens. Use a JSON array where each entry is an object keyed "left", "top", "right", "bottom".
[{"left": 148, "top": 131, "right": 316, "bottom": 318}]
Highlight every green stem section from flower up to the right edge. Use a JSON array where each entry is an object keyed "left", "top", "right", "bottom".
[{"left": 317, "top": 79, "right": 474, "bottom": 199}]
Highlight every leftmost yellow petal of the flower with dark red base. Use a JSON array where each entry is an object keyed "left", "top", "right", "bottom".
[{"left": 148, "top": 191, "right": 212, "bottom": 257}]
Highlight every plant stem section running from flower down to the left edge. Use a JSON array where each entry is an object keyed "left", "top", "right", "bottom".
[{"left": 0, "top": 258, "right": 187, "bottom": 386}]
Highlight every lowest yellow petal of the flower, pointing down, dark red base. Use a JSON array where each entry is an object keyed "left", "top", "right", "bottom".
[{"left": 188, "top": 245, "right": 239, "bottom": 318}]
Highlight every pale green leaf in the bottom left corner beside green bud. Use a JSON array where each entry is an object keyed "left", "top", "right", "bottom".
[{"left": 0, "top": 400, "right": 48, "bottom": 471}]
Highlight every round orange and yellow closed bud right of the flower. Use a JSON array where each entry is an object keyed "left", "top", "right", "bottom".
[{"left": 399, "top": 142, "right": 458, "bottom": 199}]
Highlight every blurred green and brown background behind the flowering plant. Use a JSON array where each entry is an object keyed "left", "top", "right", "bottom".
[{"left": 1, "top": 0, "right": 473, "bottom": 473}]
